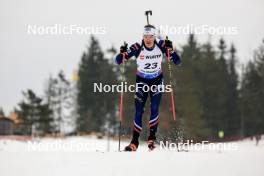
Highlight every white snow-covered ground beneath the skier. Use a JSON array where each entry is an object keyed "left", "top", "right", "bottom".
[{"left": 0, "top": 137, "right": 264, "bottom": 176}]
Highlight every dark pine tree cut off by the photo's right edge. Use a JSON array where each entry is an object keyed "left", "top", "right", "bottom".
[{"left": 240, "top": 40, "right": 264, "bottom": 136}]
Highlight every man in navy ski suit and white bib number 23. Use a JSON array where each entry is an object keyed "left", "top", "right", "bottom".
[{"left": 116, "top": 24, "right": 181, "bottom": 151}]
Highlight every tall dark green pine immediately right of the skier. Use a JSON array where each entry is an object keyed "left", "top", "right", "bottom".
[{"left": 175, "top": 35, "right": 210, "bottom": 140}]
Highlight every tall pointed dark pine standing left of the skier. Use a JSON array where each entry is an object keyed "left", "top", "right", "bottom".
[{"left": 77, "top": 36, "right": 116, "bottom": 132}]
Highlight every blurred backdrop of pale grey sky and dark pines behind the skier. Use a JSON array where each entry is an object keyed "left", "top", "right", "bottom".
[{"left": 0, "top": 0, "right": 264, "bottom": 141}]
